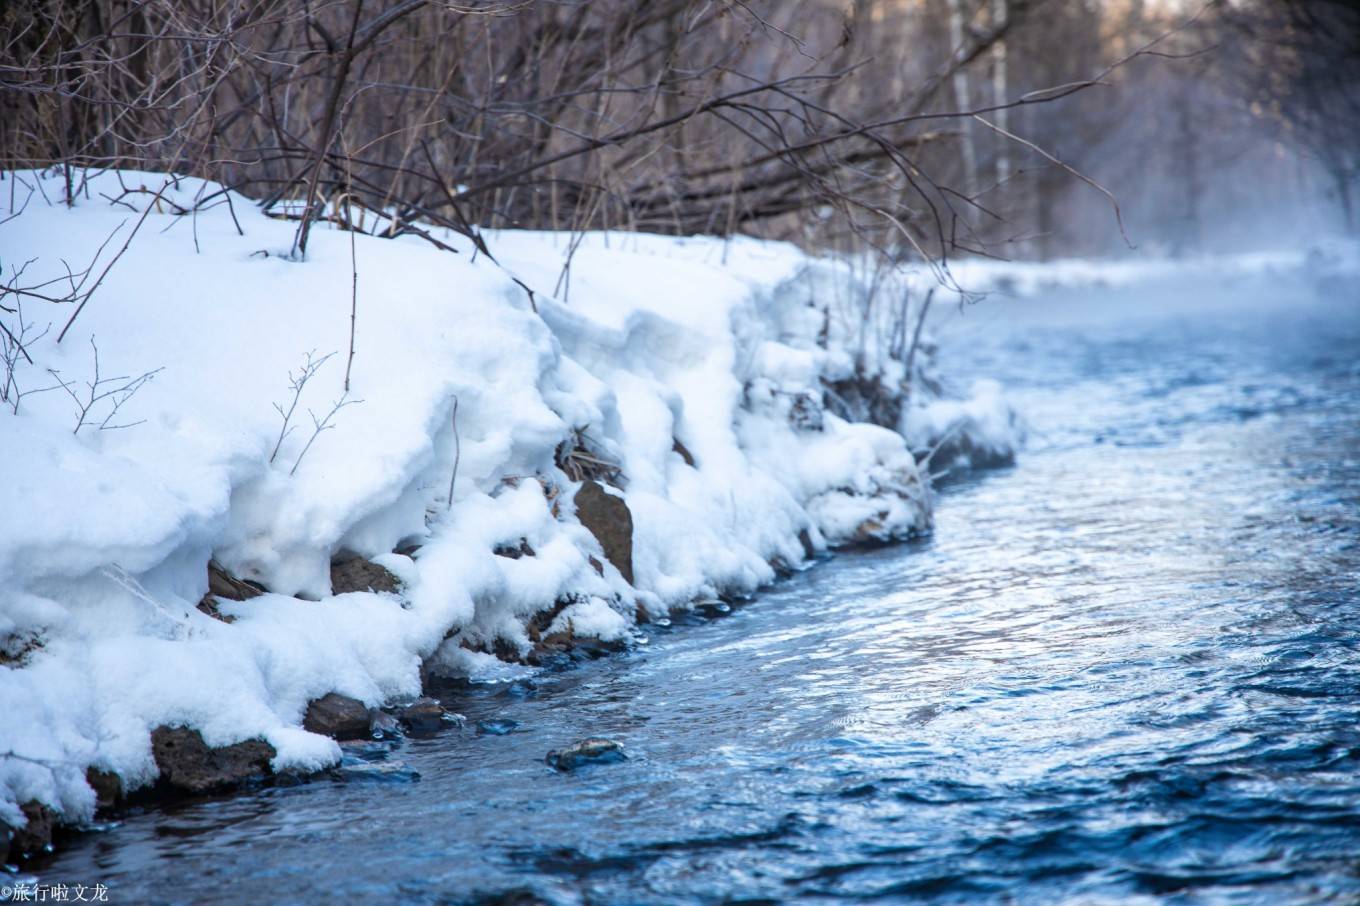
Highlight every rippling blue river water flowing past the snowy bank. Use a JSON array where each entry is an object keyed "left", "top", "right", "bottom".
[{"left": 31, "top": 257, "right": 1360, "bottom": 905}]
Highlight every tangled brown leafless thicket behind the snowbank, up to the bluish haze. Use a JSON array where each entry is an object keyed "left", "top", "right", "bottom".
[{"left": 0, "top": 0, "right": 1234, "bottom": 272}]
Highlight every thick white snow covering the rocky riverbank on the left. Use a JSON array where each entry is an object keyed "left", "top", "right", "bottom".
[{"left": 0, "top": 173, "right": 1016, "bottom": 826}]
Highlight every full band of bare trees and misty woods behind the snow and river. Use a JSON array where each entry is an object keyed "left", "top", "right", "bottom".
[{"left": 0, "top": 0, "right": 1360, "bottom": 258}]
